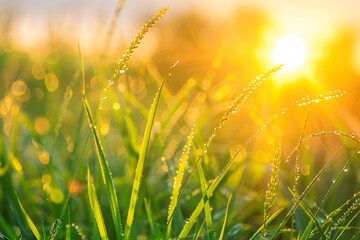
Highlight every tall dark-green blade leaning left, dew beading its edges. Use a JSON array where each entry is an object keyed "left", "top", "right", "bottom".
[{"left": 82, "top": 89, "right": 123, "bottom": 239}]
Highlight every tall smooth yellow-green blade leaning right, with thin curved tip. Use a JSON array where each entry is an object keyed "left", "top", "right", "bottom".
[{"left": 125, "top": 62, "right": 177, "bottom": 239}]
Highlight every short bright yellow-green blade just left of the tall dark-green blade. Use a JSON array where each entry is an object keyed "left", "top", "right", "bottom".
[{"left": 88, "top": 166, "right": 109, "bottom": 240}]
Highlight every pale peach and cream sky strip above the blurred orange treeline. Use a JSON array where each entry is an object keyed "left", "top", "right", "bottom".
[{"left": 0, "top": 0, "right": 360, "bottom": 73}]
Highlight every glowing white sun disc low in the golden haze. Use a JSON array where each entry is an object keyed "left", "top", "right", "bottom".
[{"left": 273, "top": 35, "right": 306, "bottom": 70}]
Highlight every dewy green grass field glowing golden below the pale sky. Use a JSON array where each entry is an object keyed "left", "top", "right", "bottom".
[{"left": 0, "top": 1, "right": 360, "bottom": 240}]
